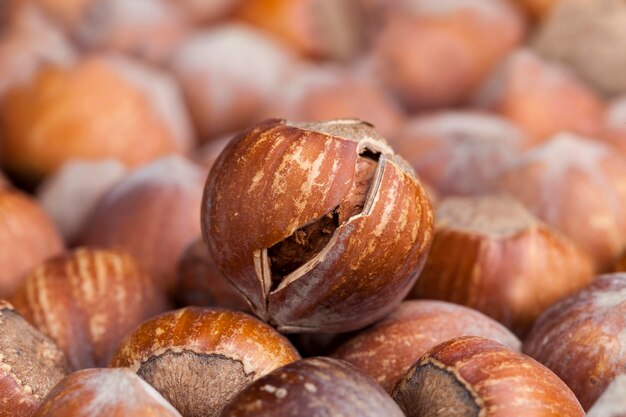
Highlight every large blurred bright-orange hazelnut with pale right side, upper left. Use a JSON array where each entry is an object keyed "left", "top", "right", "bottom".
[{"left": 0, "top": 56, "right": 190, "bottom": 180}]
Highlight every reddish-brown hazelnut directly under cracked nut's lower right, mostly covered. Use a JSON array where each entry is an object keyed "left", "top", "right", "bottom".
[{"left": 332, "top": 300, "right": 522, "bottom": 392}]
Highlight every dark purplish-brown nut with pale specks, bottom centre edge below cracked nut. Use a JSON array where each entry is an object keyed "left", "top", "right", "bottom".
[{"left": 221, "top": 357, "right": 404, "bottom": 417}]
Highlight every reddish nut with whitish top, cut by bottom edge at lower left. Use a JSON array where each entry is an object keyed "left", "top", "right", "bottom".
[{"left": 34, "top": 369, "right": 181, "bottom": 417}]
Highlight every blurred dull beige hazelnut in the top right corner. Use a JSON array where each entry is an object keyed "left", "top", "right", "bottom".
[{"left": 534, "top": 0, "right": 626, "bottom": 94}]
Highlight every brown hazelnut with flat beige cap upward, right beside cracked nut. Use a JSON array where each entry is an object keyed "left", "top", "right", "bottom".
[{"left": 411, "top": 196, "right": 593, "bottom": 335}]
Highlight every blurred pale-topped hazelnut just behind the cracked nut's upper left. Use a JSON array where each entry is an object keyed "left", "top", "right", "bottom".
[{"left": 171, "top": 23, "right": 296, "bottom": 142}]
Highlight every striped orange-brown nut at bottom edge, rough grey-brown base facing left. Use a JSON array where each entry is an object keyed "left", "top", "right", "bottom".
[{"left": 392, "top": 336, "right": 585, "bottom": 417}]
